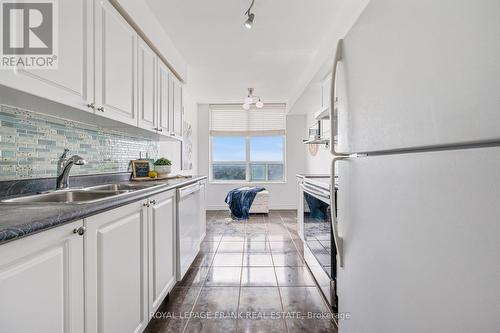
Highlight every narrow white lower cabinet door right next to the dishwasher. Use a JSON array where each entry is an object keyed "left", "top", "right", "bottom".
[{"left": 148, "top": 191, "right": 176, "bottom": 312}]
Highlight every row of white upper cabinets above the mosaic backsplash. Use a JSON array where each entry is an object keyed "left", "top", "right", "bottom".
[{"left": 0, "top": 0, "right": 182, "bottom": 139}]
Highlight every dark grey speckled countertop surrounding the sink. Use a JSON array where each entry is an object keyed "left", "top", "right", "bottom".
[{"left": 0, "top": 176, "right": 206, "bottom": 244}]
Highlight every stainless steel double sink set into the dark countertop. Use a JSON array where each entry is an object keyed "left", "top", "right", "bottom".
[{"left": 2, "top": 190, "right": 129, "bottom": 204}]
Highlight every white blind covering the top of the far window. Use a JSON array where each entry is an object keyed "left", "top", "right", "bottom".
[{"left": 210, "top": 104, "right": 286, "bottom": 136}]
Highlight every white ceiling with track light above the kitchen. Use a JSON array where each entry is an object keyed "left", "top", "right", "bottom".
[{"left": 146, "top": 0, "right": 364, "bottom": 103}]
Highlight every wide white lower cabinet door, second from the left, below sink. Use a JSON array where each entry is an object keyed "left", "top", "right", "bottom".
[{"left": 84, "top": 202, "right": 148, "bottom": 333}]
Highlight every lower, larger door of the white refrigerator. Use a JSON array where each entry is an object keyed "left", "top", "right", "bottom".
[{"left": 337, "top": 148, "right": 500, "bottom": 333}]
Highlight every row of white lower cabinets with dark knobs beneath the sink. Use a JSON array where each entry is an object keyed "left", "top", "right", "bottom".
[{"left": 0, "top": 184, "right": 191, "bottom": 333}]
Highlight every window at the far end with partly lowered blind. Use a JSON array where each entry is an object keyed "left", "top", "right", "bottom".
[{"left": 210, "top": 105, "right": 285, "bottom": 182}]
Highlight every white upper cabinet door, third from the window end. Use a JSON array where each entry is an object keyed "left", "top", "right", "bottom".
[{"left": 137, "top": 40, "right": 157, "bottom": 131}]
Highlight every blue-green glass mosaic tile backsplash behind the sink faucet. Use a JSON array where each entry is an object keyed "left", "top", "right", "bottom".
[{"left": 0, "top": 105, "right": 159, "bottom": 180}]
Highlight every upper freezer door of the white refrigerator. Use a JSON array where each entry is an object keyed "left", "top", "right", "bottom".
[{"left": 337, "top": 0, "right": 500, "bottom": 153}]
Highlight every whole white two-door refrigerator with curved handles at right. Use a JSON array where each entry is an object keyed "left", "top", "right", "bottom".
[{"left": 330, "top": 0, "right": 500, "bottom": 333}]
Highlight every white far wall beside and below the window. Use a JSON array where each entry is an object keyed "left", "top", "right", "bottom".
[{"left": 198, "top": 104, "right": 305, "bottom": 210}]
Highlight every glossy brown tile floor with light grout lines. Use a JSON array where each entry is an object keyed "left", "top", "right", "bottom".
[{"left": 145, "top": 210, "right": 337, "bottom": 333}]
